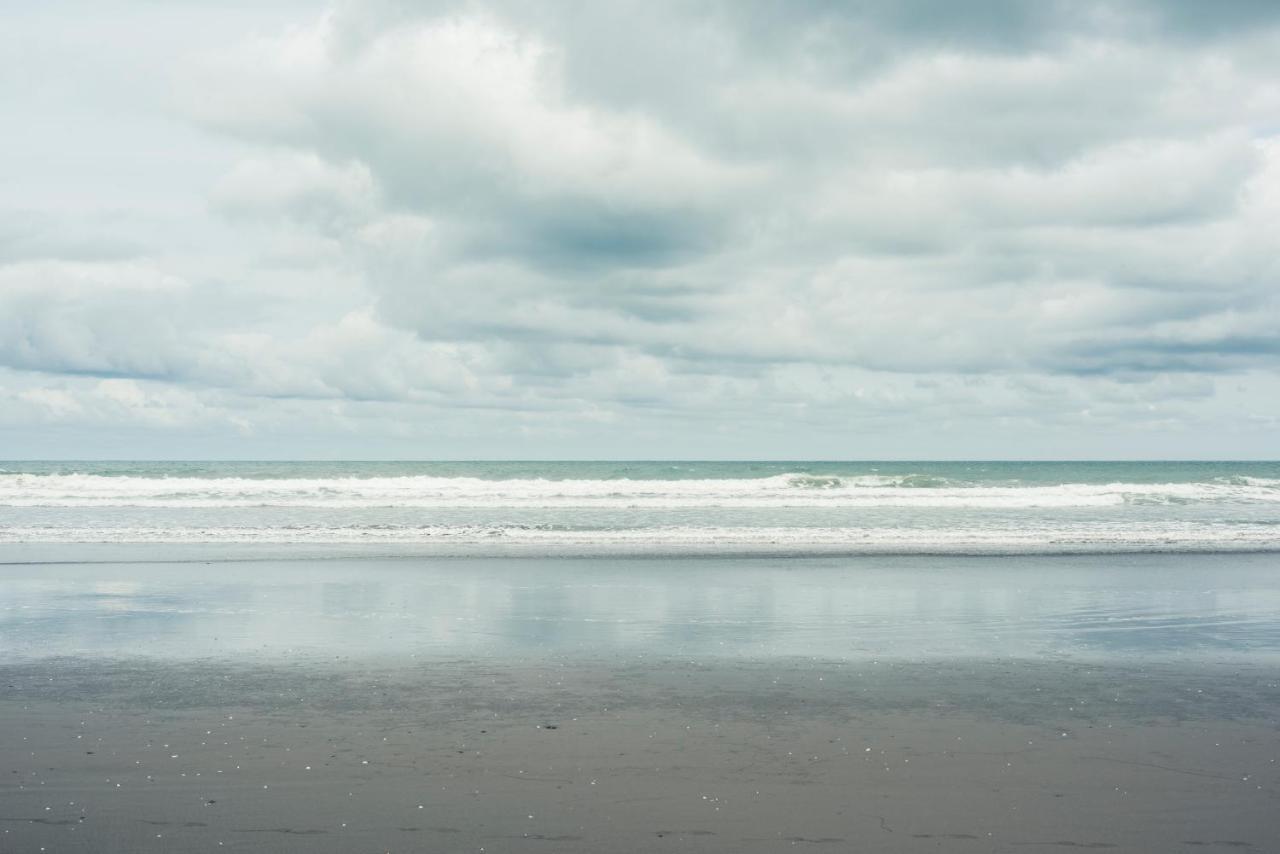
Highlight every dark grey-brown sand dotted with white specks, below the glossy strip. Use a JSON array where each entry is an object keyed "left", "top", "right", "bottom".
[{"left": 0, "top": 657, "right": 1280, "bottom": 853}]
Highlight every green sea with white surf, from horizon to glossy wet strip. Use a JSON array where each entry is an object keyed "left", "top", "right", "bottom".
[{"left": 0, "top": 462, "right": 1280, "bottom": 554}]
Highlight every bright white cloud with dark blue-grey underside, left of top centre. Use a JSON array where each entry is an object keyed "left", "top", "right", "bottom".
[{"left": 186, "top": 15, "right": 748, "bottom": 266}]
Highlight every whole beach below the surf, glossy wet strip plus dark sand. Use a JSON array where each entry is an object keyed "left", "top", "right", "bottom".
[{"left": 0, "top": 545, "right": 1280, "bottom": 851}]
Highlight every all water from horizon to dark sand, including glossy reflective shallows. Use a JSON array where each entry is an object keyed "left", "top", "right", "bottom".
[{"left": 0, "top": 462, "right": 1280, "bottom": 662}]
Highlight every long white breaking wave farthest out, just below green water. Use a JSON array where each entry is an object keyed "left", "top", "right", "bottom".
[{"left": 0, "top": 474, "right": 1280, "bottom": 508}]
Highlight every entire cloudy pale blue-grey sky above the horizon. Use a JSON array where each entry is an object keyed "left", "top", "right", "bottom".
[{"left": 0, "top": 0, "right": 1280, "bottom": 460}]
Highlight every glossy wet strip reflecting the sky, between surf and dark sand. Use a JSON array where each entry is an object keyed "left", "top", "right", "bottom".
[{"left": 0, "top": 547, "right": 1280, "bottom": 662}]
